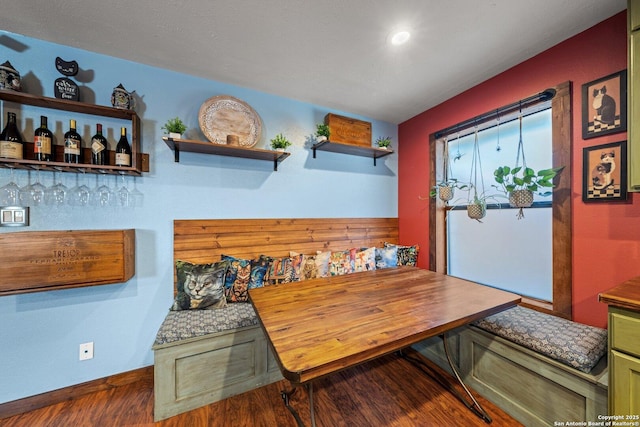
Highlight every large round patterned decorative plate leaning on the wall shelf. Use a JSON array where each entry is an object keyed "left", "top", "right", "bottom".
[{"left": 198, "top": 95, "right": 262, "bottom": 147}]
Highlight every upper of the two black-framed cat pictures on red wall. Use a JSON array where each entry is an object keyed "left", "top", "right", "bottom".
[{"left": 582, "top": 70, "right": 627, "bottom": 139}]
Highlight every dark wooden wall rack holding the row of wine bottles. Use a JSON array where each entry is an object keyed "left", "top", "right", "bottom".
[{"left": 0, "top": 90, "right": 149, "bottom": 176}]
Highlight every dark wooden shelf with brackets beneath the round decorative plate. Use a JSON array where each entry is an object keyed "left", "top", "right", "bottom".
[{"left": 162, "top": 136, "right": 291, "bottom": 171}]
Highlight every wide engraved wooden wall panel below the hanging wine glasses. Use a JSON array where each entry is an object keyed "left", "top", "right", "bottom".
[{"left": 0, "top": 229, "right": 135, "bottom": 295}]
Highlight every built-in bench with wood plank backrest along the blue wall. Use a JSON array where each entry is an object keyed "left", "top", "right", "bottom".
[{"left": 153, "top": 218, "right": 398, "bottom": 421}]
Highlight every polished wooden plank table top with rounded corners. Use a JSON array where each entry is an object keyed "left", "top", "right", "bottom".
[{"left": 249, "top": 267, "right": 520, "bottom": 384}]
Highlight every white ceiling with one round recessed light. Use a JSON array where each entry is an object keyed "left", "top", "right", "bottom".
[{"left": 0, "top": 0, "right": 626, "bottom": 123}]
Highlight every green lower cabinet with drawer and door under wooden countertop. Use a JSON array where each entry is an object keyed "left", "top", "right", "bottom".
[{"left": 609, "top": 306, "right": 640, "bottom": 414}]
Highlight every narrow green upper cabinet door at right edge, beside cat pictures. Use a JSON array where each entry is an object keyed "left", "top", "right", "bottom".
[{"left": 627, "top": 30, "right": 640, "bottom": 191}]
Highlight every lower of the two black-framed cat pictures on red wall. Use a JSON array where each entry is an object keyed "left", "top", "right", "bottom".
[{"left": 582, "top": 141, "right": 627, "bottom": 202}]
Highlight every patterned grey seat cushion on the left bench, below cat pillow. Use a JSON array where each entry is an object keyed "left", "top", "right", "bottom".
[{"left": 154, "top": 303, "right": 258, "bottom": 345}]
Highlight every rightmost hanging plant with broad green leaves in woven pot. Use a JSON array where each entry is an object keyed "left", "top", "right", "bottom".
[{"left": 493, "top": 114, "right": 564, "bottom": 219}]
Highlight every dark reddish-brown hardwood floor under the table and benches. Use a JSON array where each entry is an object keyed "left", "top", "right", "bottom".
[{"left": 0, "top": 350, "right": 521, "bottom": 427}]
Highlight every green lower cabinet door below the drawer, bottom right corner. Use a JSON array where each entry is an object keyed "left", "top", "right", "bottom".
[{"left": 609, "top": 350, "right": 640, "bottom": 414}]
